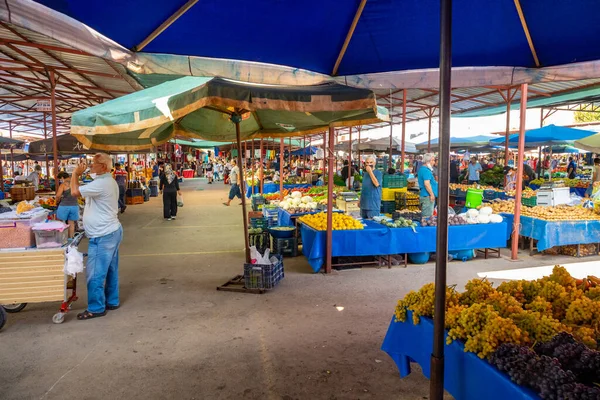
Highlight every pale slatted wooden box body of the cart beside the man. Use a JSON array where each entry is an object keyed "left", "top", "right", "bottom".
[{"left": 0, "top": 248, "right": 65, "bottom": 304}]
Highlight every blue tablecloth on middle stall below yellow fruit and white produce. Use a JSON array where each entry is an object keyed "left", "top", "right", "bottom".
[{"left": 300, "top": 221, "right": 508, "bottom": 272}]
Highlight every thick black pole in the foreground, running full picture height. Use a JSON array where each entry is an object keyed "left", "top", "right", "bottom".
[{"left": 428, "top": 0, "right": 452, "bottom": 400}]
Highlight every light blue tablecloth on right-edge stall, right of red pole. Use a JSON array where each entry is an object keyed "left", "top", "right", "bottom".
[{"left": 502, "top": 214, "right": 600, "bottom": 251}]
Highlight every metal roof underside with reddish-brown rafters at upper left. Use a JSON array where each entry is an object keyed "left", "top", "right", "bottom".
[{"left": 0, "top": 22, "right": 141, "bottom": 141}]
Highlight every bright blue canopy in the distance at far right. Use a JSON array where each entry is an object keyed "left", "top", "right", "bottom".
[{"left": 490, "top": 125, "right": 596, "bottom": 146}]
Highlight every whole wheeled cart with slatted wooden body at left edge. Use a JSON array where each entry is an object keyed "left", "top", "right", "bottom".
[{"left": 0, "top": 233, "right": 84, "bottom": 329}]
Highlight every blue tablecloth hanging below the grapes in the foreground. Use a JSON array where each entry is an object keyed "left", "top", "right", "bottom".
[{"left": 381, "top": 316, "right": 539, "bottom": 400}]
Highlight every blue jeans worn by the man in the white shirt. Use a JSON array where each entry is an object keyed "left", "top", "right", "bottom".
[{"left": 86, "top": 227, "right": 123, "bottom": 313}]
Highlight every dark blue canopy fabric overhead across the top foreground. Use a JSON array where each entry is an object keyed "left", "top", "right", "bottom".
[{"left": 38, "top": 0, "right": 600, "bottom": 75}]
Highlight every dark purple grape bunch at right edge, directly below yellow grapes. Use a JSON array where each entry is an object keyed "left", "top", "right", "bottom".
[{"left": 533, "top": 332, "right": 600, "bottom": 385}]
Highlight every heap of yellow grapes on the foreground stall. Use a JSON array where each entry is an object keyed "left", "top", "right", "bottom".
[{"left": 395, "top": 266, "right": 600, "bottom": 358}]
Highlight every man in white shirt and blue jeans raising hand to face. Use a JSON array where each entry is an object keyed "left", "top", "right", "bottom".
[{"left": 71, "top": 153, "right": 123, "bottom": 320}]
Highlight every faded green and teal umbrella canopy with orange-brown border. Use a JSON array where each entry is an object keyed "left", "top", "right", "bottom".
[{"left": 71, "top": 76, "right": 389, "bottom": 151}]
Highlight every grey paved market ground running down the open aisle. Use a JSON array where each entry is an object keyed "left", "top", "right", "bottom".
[{"left": 0, "top": 179, "right": 596, "bottom": 400}]
